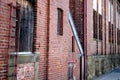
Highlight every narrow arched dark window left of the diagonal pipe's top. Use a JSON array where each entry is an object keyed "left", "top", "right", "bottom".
[{"left": 57, "top": 8, "right": 63, "bottom": 35}]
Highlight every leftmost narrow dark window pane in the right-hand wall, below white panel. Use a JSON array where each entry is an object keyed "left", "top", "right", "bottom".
[{"left": 93, "top": 10, "right": 98, "bottom": 39}]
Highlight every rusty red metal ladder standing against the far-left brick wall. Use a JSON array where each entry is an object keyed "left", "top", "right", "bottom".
[{"left": 7, "top": 3, "right": 20, "bottom": 80}]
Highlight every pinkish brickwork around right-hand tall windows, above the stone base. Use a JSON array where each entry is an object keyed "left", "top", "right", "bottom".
[{"left": 87, "top": 0, "right": 116, "bottom": 55}]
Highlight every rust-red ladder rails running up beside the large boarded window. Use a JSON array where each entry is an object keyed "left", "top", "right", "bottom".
[{"left": 7, "top": 3, "right": 20, "bottom": 80}]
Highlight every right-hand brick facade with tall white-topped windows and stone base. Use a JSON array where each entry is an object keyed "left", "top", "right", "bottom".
[{"left": 87, "top": 0, "right": 120, "bottom": 79}]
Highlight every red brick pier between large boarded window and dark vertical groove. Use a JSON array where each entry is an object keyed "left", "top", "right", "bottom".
[{"left": 34, "top": 0, "right": 48, "bottom": 80}]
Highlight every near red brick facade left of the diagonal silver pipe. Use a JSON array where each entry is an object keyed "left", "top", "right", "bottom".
[{"left": 0, "top": 0, "right": 80, "bottom": 80}]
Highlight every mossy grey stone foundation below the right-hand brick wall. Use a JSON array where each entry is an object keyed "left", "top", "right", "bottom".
[{"left": 87, "top": 55, "right": 120, "bottom": 80}]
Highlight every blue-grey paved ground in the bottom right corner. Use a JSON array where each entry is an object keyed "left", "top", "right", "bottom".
[{"left": 94, "top": 68, "right": 120, "bottom": 80}]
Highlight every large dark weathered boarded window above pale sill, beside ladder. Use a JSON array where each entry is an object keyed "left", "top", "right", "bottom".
[{"left": 18, "top": 0, "right": 34, "bottom": 52}]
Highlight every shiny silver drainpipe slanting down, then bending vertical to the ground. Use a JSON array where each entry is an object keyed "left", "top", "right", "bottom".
[{"left": 68, "top": 12, "right": 84, "bottom": 80}]
